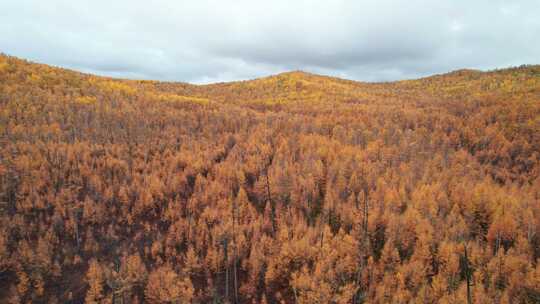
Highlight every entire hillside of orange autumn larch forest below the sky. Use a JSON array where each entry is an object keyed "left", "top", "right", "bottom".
[{"left": 0, "top": 55, "right": 540, "bottom": 304}]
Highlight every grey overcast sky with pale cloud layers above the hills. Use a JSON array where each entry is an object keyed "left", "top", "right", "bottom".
[{"left": 0, "top": 0, "right": 540, "bottom": 83}]
